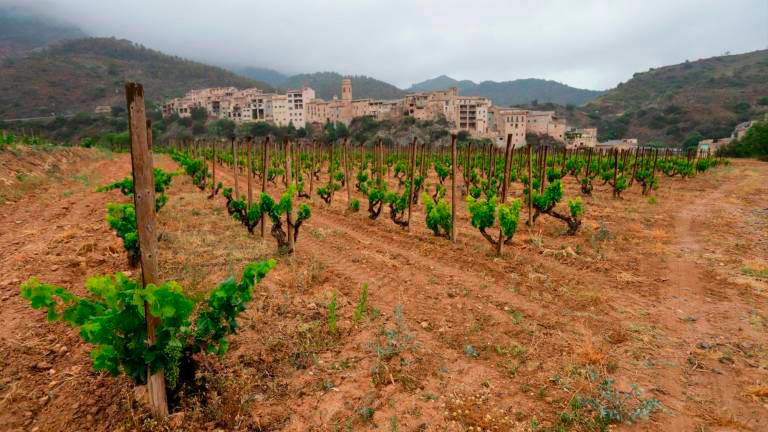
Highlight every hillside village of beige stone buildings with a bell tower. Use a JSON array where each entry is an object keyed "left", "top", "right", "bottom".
[{"left": 162, "top": 79, "right": 608, "bottom": 149}]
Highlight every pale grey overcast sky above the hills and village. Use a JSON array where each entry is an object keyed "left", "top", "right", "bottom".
[{"left": 6, "top": 0, "right": 768, "bottom": 89}]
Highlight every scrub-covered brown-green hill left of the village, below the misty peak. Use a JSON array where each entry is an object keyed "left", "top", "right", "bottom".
[{"left": 0, "top": 38, "right": 269, "bottom": 118}]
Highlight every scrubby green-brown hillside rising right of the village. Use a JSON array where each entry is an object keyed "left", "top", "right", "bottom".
[{"left": 569, "top": 50, "right": 768, "bottom": 144}]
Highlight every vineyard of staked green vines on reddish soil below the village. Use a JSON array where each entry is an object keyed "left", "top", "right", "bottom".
[{"left": 0, "top": 85, "right": 768, "bottom": 431}]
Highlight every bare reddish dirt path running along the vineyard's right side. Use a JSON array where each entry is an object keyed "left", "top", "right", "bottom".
[{"left": 652, "top": 164, "right": 768, "bottom": 430}]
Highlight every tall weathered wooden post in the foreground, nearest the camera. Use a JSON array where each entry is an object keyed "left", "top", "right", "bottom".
[{"left": 125, "top": 82, "right": 168, "bottom": 417}]
